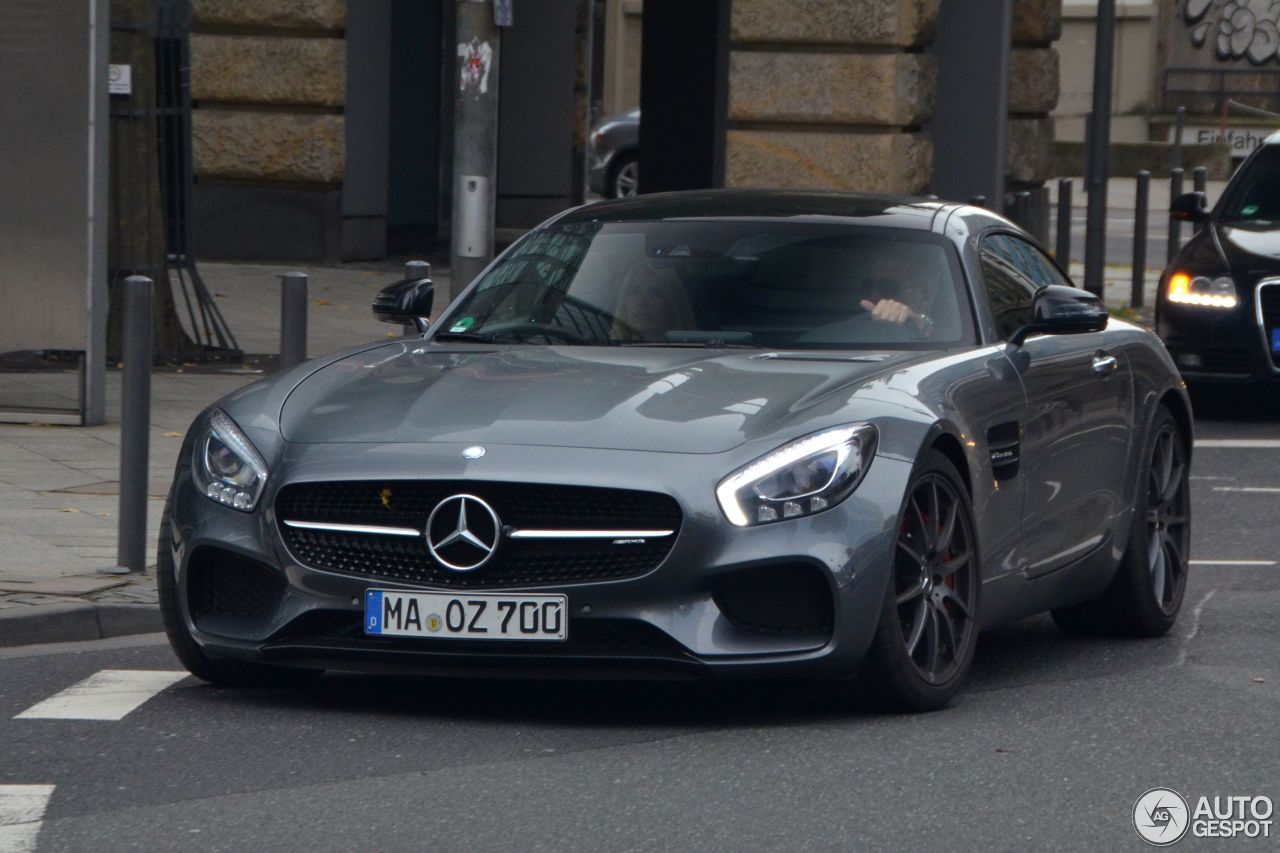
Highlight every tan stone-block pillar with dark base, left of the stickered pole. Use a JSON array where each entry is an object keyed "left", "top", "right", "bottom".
[{"left": 191, "top": 0, "right": 355, "bottom": 259}]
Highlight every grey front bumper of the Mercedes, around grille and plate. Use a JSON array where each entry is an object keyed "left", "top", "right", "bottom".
[{"left": 172, "top": 444, "right": 910, "bottom": 678}]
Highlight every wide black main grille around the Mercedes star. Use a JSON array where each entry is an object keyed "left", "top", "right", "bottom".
[{"left": 275, "top": 480, "right": 681, "bottom": 589}]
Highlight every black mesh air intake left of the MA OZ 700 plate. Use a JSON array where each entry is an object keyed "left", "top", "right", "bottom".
[{"left": 187, "top": 547, "right": 285, "bottom": 624}]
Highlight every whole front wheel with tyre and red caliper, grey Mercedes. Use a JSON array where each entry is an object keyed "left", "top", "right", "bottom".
[{"left": 859, "top": 451, "right": 979, "bottom": 711}]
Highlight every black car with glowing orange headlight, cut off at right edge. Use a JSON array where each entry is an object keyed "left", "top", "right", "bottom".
[{"left": 1156, "top": 133, "right": 1280, "bottom": 383}]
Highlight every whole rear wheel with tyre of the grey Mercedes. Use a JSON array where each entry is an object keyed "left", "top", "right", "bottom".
[{"left": 1053, "top": 407, "right": 1190, "bottom": 637}]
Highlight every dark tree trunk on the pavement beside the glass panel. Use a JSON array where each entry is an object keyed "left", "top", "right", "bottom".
[{"left": 106, "top": 0, "right": 198, "bottom": 361}]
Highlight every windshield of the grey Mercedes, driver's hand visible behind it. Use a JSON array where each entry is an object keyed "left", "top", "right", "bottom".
[{"left": 435, "top": 219, "right": 973, "bottom": 350}]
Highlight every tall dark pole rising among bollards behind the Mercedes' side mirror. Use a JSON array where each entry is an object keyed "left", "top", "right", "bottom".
[{"left": 1084, "top": 0, "right": 1116, "bottom": 296}]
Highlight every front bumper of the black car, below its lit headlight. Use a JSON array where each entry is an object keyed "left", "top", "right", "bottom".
[{"left": 1156, "top": 280, "right": 1280, "bottom": 383}]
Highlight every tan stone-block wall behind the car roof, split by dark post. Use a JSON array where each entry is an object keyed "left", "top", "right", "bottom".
[{"left": 724, "top": 0, "right": 1061, "bottom": 207}]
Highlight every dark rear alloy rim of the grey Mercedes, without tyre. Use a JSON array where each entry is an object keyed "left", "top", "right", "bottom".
[{"left": 1147, "top": 424, "right": 1190, "bottom": 613}]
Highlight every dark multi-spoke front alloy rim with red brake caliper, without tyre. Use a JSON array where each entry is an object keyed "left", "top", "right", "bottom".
[{"left": 893, "top": 474, "right": 977, "bottom": 684}]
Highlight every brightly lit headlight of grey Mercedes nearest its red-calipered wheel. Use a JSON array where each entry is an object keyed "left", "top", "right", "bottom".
[{"left": 716, "top": 424, "right": 876, "bottom": 528}]
